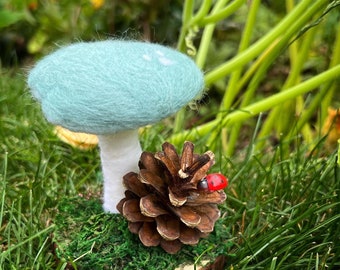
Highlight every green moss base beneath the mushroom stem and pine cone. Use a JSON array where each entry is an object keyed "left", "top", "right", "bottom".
[{"left": 54, "top": 197, "right": 230, "bottom": 270}]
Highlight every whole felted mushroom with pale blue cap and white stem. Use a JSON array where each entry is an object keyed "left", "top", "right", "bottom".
[{"left": 28, "top": 40, "right": 204, "bottom": 213}]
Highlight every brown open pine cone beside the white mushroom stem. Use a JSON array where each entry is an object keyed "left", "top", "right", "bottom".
[{"left": 117, "top": 142, "right": 226, "bottom": 254}]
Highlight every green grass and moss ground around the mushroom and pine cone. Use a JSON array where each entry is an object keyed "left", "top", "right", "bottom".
[{"left": 0, "top": 69, "right": 340, "bottom": 269}]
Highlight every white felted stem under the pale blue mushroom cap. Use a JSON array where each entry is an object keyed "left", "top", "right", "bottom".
[{"left": 98, "top": 130, "right": 142, "bottom": 213}]
